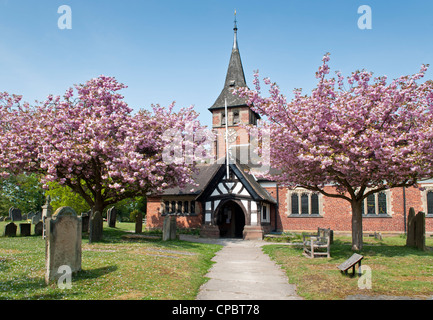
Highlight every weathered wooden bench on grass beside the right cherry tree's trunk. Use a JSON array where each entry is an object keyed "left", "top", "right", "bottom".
[{"left": 302, "top": 228, "right": 332, "bottom": 258}]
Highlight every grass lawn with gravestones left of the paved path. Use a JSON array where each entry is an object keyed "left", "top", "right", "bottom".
[{"left": 0, "top": 222, "right": 221, "bottom": 300}]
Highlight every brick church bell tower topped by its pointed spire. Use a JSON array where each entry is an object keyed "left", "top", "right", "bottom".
[{"left": 209, "top": 11, "right": 260, "bottom": 160}]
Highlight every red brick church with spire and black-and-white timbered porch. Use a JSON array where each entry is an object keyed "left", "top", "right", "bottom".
[{"left": 147, "top": 22, "right": 433, "bottom": 239}]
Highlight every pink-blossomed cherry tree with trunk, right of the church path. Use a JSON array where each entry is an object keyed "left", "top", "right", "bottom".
[{"left": 235, "top": 54, "right": 433, "bottom": 250}]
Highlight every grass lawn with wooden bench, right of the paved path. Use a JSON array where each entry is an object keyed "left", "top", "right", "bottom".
[{"left": 264, "top": 236, "right": 433, "bottom": 300}]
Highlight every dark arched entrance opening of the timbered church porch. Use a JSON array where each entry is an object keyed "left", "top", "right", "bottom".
[{"left": 216, "top": 200, "right": 245, "bottom": 238}]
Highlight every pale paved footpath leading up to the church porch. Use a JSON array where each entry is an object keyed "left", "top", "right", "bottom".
[{"left": 181, "top": 239, "right": 302, "bottom": 300}]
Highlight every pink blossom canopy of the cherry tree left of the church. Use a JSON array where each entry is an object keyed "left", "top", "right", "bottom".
[{"left": 0, "top": 76, "right": 206, "bottom": 212}]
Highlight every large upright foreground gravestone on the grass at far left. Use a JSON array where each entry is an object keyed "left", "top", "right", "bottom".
[{"left": 45, "top": 207, "right": 81, "bottom": 285}]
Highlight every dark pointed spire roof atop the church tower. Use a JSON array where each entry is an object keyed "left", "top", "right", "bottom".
[{"left": 209, "top": 11, "right": 247, "bottom": 110}]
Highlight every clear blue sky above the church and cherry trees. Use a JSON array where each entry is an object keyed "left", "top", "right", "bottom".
[{"left": 0, "top": 0, "right": 433, "bottom": 129}]
